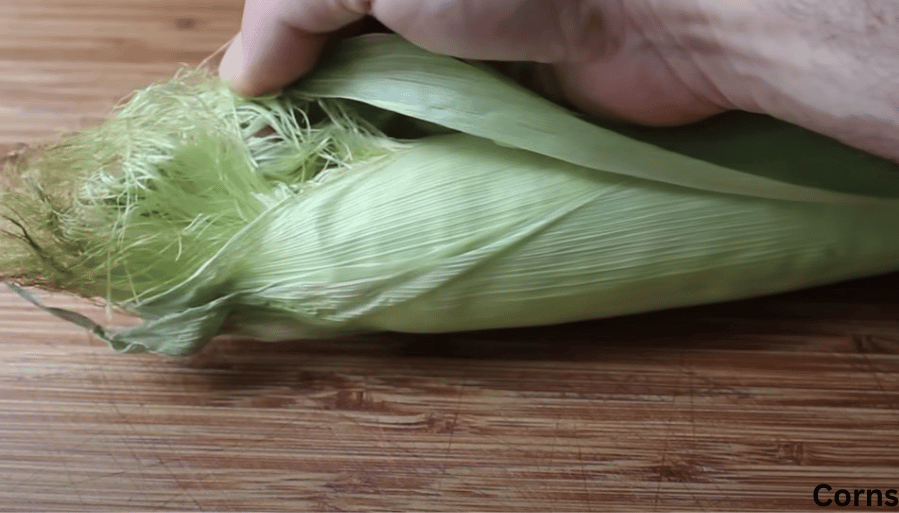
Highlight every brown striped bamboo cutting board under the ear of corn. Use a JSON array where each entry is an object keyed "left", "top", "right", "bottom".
[{"left": 0, "top": 0, "right": 899, "bottom": 512}]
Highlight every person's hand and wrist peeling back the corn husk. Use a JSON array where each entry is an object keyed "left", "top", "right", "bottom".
[{"left": 221, "top": 0, "right": 899, "bottom": 160}]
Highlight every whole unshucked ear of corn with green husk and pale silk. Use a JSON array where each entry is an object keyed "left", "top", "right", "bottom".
[{"left": 0, "top": 35, "right": 899, "bottom": 355}]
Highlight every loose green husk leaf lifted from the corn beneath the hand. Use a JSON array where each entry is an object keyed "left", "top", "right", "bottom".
[{"left": 299, "top": 34, "right": 899, "bottom": 202}]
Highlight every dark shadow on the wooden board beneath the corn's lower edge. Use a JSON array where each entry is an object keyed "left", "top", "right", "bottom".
[{"left": 175, "top": 273, "right": 899, "bottom": 394}]
